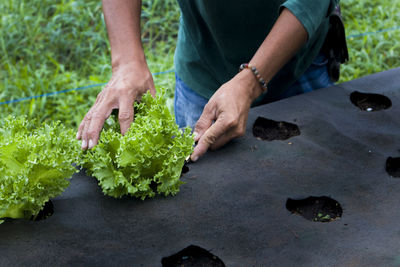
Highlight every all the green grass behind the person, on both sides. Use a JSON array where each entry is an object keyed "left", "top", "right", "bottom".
[{"left": 0, "top": 0, "right": 400, "bottom": 127}]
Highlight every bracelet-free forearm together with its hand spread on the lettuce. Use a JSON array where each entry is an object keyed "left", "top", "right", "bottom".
[{"left": 76, "top": 0, "right": 156, "bottom": 150}]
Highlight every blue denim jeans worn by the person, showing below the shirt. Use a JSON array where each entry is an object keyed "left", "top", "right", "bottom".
[{"left": 174, "top": 54, "right": 333, "bottom": 129}]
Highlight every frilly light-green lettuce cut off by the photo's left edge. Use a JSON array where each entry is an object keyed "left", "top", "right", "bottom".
[{"left": 0, "top": 116, "right": 79, "bottom": 223}]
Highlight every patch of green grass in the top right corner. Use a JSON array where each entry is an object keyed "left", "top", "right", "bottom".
[{"left": 340, "top": 0, "right": 400, "bottom": 82}]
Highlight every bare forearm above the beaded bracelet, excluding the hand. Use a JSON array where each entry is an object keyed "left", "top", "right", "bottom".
[{"left": 250, "top": 8, "right": 308, "bottom": 99}]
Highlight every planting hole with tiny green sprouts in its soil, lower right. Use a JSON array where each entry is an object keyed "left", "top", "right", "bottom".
[{"left": 286, "top": 196, "right": 343, "bottom": 222}]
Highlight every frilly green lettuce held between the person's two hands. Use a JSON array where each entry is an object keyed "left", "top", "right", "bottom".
[{"left": 84, "top": 91, "right": 194, "bottom": 199}]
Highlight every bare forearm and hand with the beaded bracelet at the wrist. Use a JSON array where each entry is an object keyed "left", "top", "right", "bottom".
[{"left": 191, "top": 9, "right": 308, "bottom": 161}]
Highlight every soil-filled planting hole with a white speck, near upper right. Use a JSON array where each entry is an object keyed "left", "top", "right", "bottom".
[{"left": 350, "top": 91, "right": 392, "bottom": 111}]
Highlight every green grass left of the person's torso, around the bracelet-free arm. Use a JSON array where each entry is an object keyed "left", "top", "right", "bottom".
[{"left": 0, "top": 0, "right": 179, "bottom": 127}]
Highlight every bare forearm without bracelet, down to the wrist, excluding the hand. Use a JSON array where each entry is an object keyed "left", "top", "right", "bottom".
[{"left": 103, "top": 0, "right": 145, "bottom": 68}]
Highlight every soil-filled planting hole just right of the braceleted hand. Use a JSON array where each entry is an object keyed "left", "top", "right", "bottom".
[{"left": 253, "top": 117, "right": 300, "bottom": 141}]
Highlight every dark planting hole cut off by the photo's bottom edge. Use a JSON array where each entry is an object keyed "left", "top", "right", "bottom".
[{"left": 161, "top": 245, "right": 225, "bottom": 267}]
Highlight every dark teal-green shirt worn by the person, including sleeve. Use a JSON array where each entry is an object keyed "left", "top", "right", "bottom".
[{"left": 175, "top": 0, "right": 339, "bottom": 104}]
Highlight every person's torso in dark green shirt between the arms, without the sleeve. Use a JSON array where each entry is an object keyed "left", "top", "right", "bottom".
[{"left": 175, "top": 0, "right": 332, "bottom": 103}]
